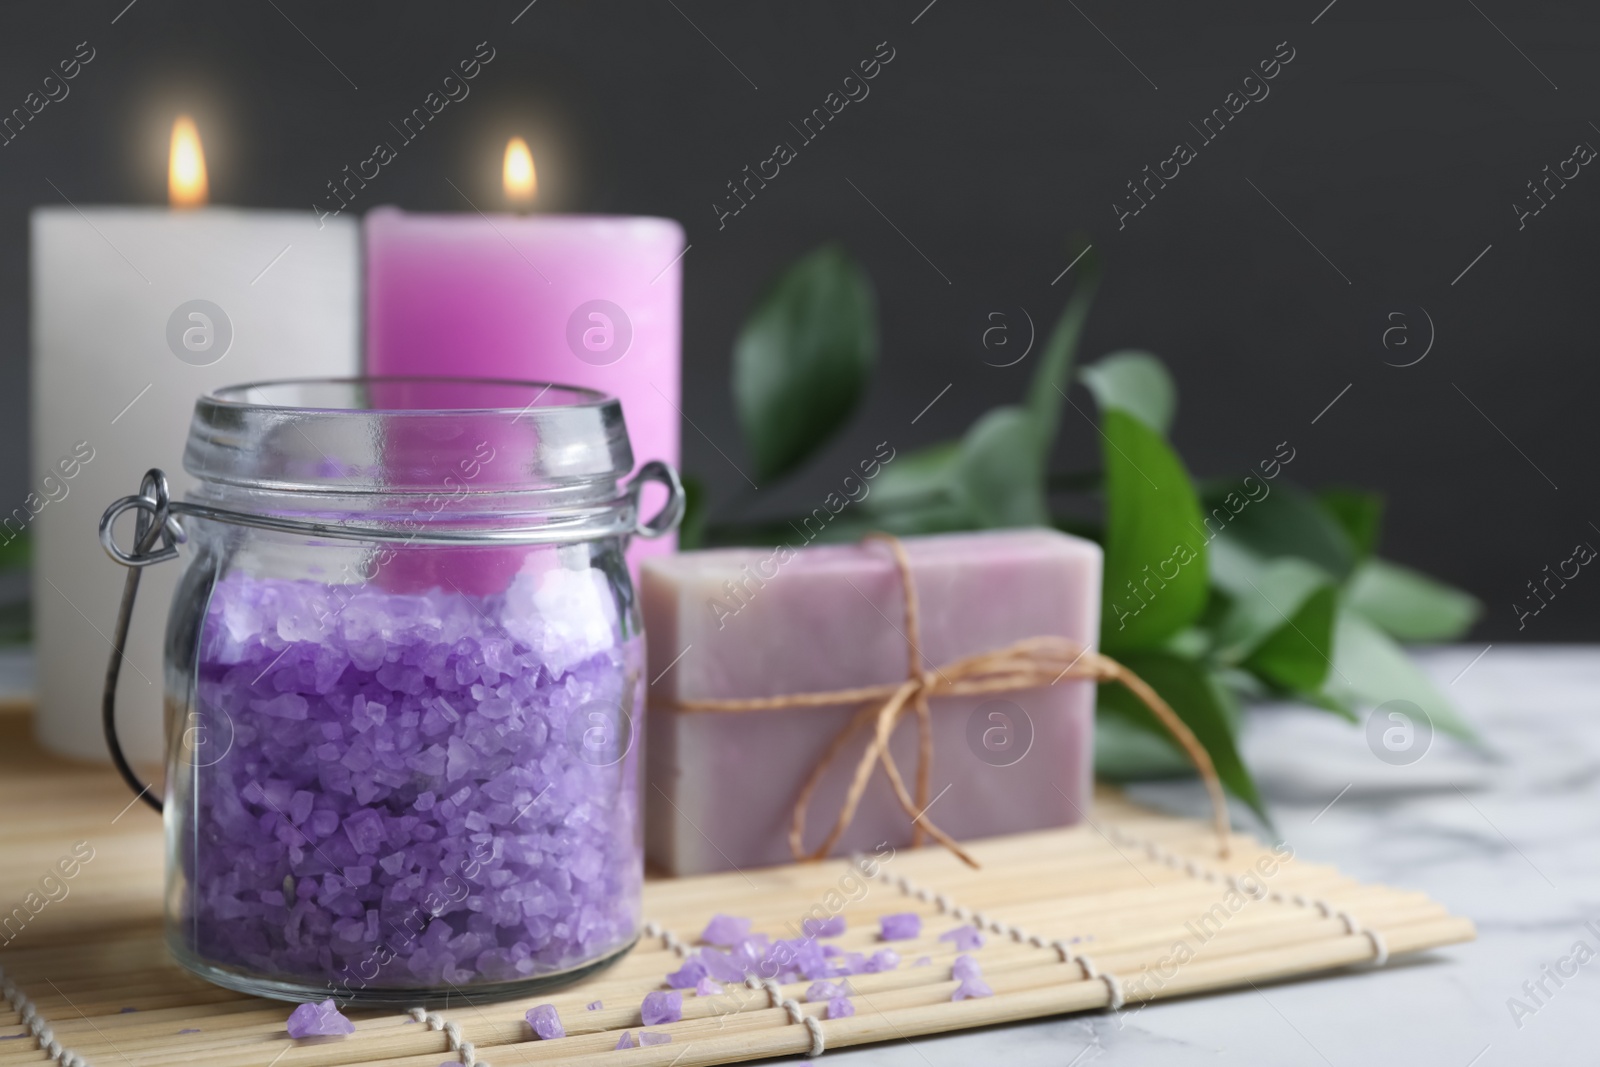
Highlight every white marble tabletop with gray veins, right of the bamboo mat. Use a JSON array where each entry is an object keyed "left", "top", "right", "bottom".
[{"left": 824, "top": 645, "right": 1600, "bottom": 1067}]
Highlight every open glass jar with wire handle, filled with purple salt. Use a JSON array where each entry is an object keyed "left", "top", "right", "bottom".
[{"left": 101, "top": 379, "right": 683, "bottom": 1006}]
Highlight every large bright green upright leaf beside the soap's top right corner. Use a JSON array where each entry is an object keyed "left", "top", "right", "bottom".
[{"left": 1101, "top": 408, "right": 1210, "bottom": 653}]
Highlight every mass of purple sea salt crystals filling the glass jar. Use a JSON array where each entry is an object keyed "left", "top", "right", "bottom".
[{"left": 174, "top": 572, "right": 643, "bottom": 992}]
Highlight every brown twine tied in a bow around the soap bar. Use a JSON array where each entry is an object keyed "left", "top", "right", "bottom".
[{"left": 674, "top": 533, "right": 1229, "bottom": 867}]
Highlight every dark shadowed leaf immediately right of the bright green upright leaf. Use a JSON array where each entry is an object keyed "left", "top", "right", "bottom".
[{"left": 1205, "top": 475, "right": 1355, "bottom": 581}]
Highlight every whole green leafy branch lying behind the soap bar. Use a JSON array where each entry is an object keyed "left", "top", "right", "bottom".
[{"left": 682, "top": 245, "right": 1482, "bottom": 819}]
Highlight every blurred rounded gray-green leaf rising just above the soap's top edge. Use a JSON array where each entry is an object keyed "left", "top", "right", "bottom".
[{"left": 954, "top": 405, "right": 1050, "bottom": 528}]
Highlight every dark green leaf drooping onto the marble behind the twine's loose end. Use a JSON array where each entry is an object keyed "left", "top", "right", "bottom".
[{"left": 1096, "top": 651, "right": 1269, "bottom": 821}]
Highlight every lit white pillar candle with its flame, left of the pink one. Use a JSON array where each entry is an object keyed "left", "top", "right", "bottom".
[{"left": 29, "top": 120, "right": 360, "bottom": 763}]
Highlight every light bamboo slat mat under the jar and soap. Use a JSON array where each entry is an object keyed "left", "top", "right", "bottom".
[{"left": 0, "top": 715, "right": 1474, "bottom": 1067}]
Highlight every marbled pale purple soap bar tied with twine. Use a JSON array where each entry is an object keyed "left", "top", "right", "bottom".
[{"left": 642, "top": 530, "right": 1101, "bottom": 875}]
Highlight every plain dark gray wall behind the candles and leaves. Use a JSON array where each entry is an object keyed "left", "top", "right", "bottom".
[{"left": 0, "top": 0, "right": 1600, "bottom": 640}]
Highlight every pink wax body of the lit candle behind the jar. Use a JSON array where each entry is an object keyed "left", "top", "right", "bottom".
[{"left": 366, "top": 208, "right": 683, "bottom": 565}]
